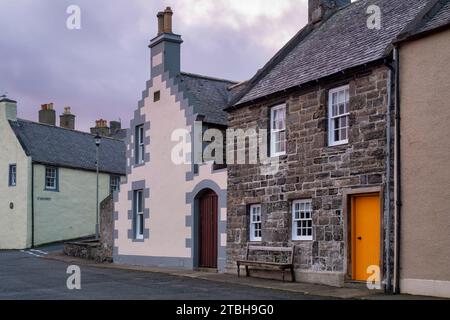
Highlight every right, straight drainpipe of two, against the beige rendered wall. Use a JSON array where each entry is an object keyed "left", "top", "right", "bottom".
[{"left": 394, "top": 46, "right": 402, "bottom": 293}]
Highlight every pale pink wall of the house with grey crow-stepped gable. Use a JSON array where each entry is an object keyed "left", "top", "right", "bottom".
[{"left": 114, "top": 72, "right": 227, "bottom": 258}]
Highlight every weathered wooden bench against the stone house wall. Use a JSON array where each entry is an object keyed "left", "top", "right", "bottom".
[{"left": 237, "top": 244, "right": 295, "bottom": 282}]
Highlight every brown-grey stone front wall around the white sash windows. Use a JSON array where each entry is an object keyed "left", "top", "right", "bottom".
[{"left": 227, "top": 66, "right": 388, "bottom": 278}]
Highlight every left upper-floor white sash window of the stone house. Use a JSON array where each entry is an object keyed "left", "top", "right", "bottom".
[{"left": 270, "top": 104, "right": 286, "bottom": 157}]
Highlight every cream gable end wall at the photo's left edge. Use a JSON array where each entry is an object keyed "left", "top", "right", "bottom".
[{"left": 0, "top": 103, "right": 31, "bottom": 249}]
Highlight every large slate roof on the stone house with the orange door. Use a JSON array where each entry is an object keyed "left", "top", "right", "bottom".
[{"left": 232, "top": 0, "right": 429, "bottom": 106}]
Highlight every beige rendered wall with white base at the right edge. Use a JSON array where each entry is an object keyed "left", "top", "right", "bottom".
[{"left": 400, "top": 30, "right": 450, "bottom": 297}]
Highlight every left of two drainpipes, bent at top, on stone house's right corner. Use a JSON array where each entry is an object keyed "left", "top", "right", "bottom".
[{"left": 384, "top": 60, "right": 395, "bottom": 292}]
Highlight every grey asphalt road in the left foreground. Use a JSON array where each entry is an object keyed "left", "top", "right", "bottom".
[{"left": 0, "top": 246, "right": 323, "bottom": 300}]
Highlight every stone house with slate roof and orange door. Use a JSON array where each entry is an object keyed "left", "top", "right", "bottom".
[{"left": 227, "top": 0, "right": 429, "bottom": 290}]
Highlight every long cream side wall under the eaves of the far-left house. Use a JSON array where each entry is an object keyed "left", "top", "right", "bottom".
[{"left": 34, "top": 164, "right": 110, "bottom": 245}]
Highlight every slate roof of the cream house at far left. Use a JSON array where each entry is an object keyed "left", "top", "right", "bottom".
[{"left": 10, "top": 119, "right": 126, "bottom": 175}]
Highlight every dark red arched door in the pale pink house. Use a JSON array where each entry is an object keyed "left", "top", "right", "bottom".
[{"left": 199, "top": 191, "right": 218, "bottom": 268}]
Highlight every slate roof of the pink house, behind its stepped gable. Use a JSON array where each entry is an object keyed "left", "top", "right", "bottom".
[{"left": 178, "top": 72, "right": 236, "bottom": 125}]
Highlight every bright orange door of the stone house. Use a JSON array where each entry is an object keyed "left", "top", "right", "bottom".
[{"left": 352, "top": 195, "right": 381, "bottom": 281}]
